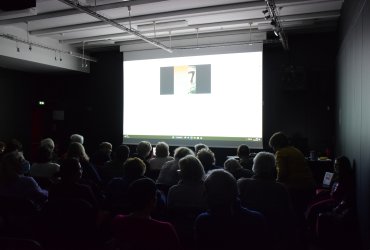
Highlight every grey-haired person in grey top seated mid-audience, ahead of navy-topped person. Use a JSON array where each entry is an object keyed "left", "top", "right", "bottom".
[{"left": 167, "top": 155, "right": 206, "bottom": 210}]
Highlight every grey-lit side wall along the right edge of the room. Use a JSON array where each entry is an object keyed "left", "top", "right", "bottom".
[{"left": 335, "top": 0, "right": 370, "bottom": 249}]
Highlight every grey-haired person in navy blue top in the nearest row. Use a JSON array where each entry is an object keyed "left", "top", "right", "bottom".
[{"left": 194, "top": 169, "right": 270, "bottom": 249}]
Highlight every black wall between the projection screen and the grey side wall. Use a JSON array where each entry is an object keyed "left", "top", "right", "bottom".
[{"left": 263, "top": 32, "right": 337, "bottom": 155}]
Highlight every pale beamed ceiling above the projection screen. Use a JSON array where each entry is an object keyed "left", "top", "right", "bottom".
[{"left": 0, "top": 0, "right": 344, "bottom": 49}]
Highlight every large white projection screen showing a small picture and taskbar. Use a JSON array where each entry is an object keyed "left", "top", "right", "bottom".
[{"left": 123, "top": 45, "right": 262, "bottom": 148}]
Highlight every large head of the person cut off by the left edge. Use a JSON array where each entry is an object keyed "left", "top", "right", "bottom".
[{"left": 0, "top": 151, "right": 24, "bottom": 182}]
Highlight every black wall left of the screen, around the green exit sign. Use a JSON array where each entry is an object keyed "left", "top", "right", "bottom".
[{"left": 28, "top": 51, "right": 123, "bottom": 156}]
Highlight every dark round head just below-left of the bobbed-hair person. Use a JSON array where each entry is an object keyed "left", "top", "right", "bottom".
[{"left": 59, "top": 158, "right": 82, "bottom": 182}]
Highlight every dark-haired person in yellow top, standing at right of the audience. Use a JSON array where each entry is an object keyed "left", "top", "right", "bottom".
[{"left": 269, "top": 132, "right": 315, "bottom": 216}]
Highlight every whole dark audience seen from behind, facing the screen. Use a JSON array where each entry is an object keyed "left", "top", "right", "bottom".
[{"left": 0, "top": 132, "right": 356, "bottom": 250}]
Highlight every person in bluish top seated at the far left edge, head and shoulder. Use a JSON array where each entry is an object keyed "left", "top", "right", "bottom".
[{"left": 0, "top": 151, "right": 48, "bottom": 205}]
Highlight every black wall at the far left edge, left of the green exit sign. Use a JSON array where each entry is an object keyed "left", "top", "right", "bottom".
[{"left": 0, "top": 68, "right": 31, "bottom": 153}]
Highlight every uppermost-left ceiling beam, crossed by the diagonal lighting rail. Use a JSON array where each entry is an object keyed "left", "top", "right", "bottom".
[{"left": 0, "top": 0, "right": 167, "bottom": 25}]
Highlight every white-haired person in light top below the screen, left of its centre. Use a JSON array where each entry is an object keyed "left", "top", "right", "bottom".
[{"left": 147, "top": 142, "right": 175, "bottom": 180}]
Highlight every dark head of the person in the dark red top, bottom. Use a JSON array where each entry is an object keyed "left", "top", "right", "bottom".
[{"left": 127, "top": 178, "right": 157, "bottom": 214}]
